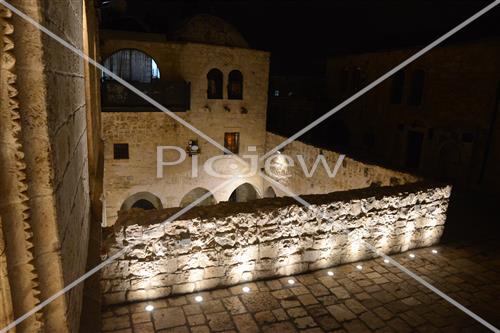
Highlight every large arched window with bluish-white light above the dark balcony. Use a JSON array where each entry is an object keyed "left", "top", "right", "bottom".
[{"left": 103, "top": 49, "right": 160, "bottom": 83}]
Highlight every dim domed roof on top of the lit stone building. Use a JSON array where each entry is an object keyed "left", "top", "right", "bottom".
[{"left": 172, "top": 14, "right": 249, "bottom": 48}]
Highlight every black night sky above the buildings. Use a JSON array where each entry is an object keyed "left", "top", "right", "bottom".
[{"left": 102, "top": 0, "right": 500, "bottom": 74}]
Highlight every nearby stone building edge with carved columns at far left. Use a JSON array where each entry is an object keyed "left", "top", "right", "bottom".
[{"left": 0, "top": 0, "right": 102, "bottom": 332}]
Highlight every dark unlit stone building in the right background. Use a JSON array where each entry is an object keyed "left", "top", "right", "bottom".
[{"left": 327, "top": 40, "right": 500, "bottom": 191}]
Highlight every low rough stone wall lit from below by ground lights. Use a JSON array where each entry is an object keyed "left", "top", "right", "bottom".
[{"left": 101, "top": 183, "right": 451, "bottom": 304}]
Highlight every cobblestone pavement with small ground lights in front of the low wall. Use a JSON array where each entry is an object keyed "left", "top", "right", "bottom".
[{"left": 103, "top": 244, "right": 500, "bottom": 333}]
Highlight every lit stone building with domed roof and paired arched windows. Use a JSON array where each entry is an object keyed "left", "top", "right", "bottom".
[{"left": 101, "top": 15, "right": 269, "bottom": 225}]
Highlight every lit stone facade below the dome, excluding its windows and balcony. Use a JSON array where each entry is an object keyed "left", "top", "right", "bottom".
[{"left": 102, "top": 32, "right": 269, "bottom": 225}]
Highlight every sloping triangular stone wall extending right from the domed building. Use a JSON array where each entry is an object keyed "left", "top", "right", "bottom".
[{"left": 264, "top": 132, "right": 420, "bottom": 196}]
